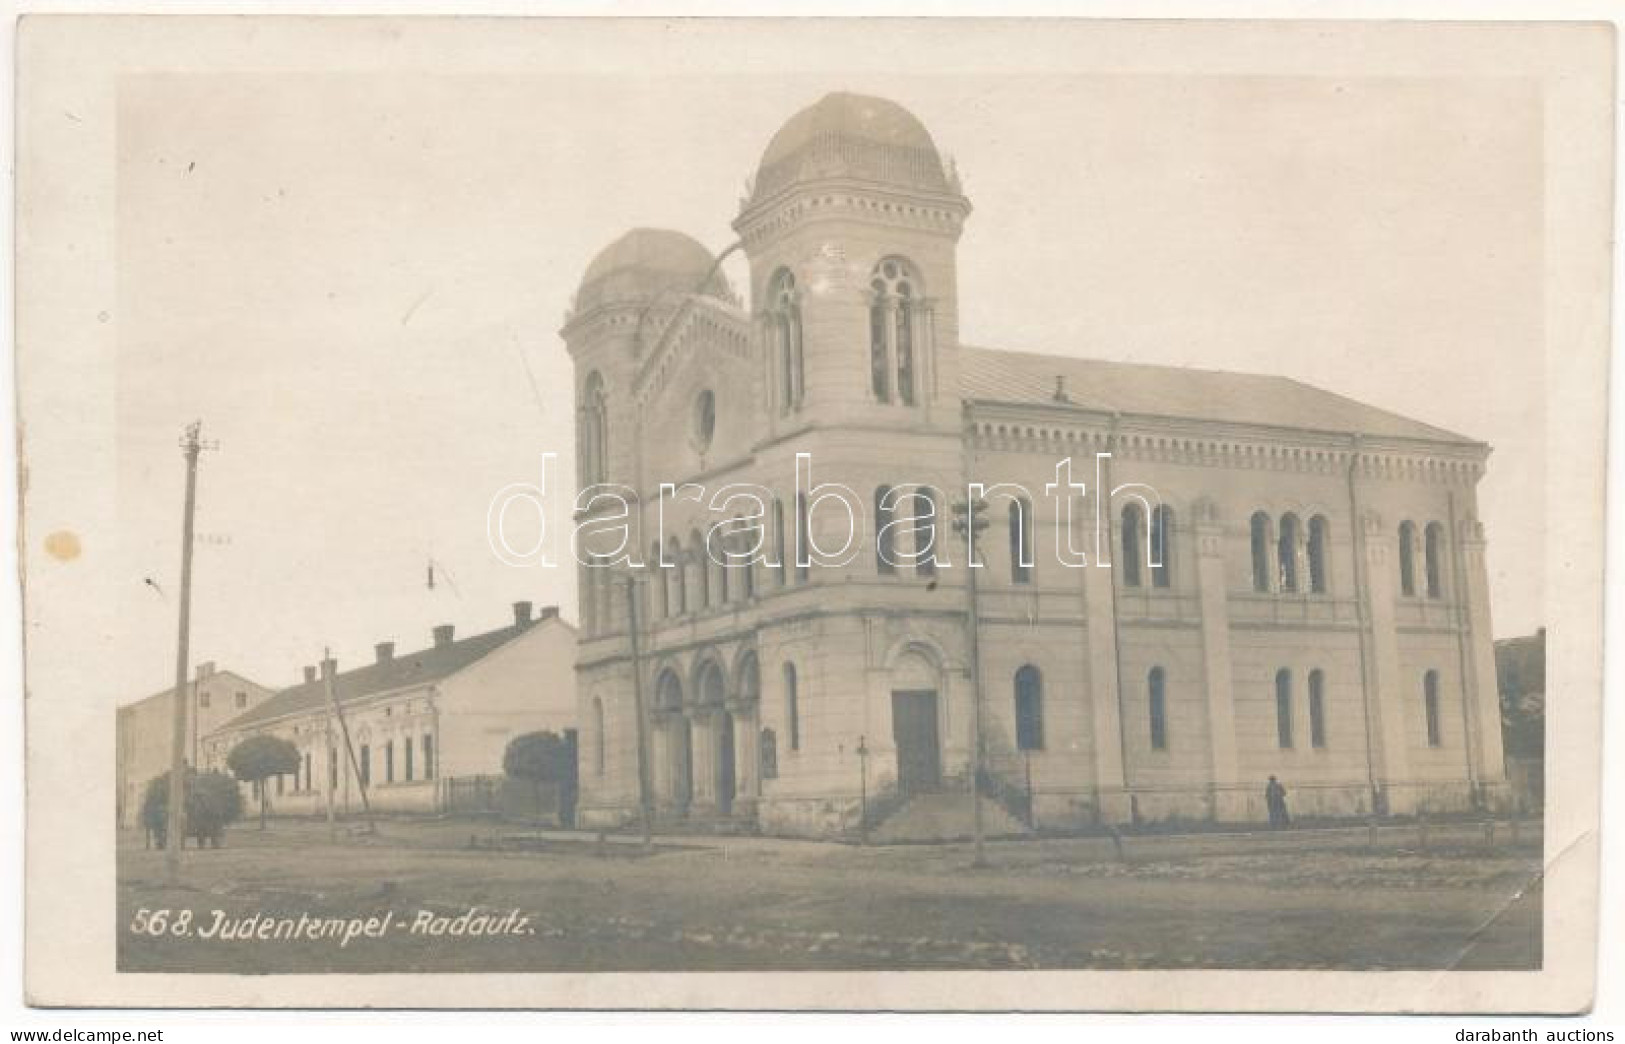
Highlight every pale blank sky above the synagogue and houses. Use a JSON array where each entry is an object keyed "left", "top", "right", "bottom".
[{"left": 117, "top": 65, "right": 1545, "bottom": 699}]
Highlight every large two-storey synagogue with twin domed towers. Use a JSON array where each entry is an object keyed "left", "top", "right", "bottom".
[{"left": 562, "top": 94, "right": 1505, "bottom": 834}]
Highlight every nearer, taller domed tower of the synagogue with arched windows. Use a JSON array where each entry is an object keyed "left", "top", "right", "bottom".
[{"left": 733, "top": 93, "right": 970, "bottom": 429}]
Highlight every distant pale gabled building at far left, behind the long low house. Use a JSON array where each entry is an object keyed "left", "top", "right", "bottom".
[{"left": 114, "top": 662, "right": 273, "bottom": 828}]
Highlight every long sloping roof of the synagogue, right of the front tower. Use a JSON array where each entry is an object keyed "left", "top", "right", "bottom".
[{"left": 959, "top": 346, "right": 1479, "bottom": 446}]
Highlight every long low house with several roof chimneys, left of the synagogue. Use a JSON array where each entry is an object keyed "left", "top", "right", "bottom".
[{"left": 203, "top": 602, "right": 577, "bottom": 815}]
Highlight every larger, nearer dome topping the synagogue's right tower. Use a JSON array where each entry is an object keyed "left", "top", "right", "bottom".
[{"left": 751, "top": 93, "right": 954, "bottom": 202}]
